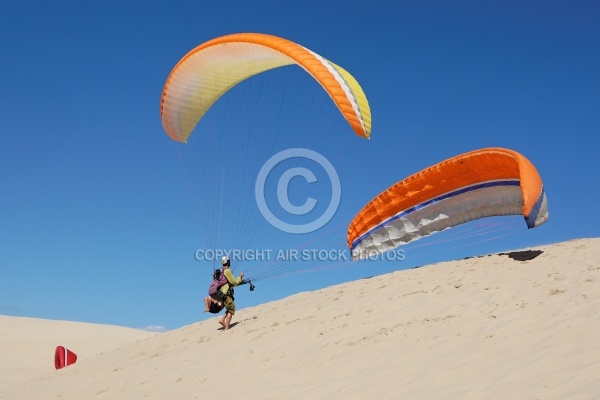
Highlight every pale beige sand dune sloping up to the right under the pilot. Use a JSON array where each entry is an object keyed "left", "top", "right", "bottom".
[{"left": 0, "top": 239, "right": 600, "bottom": 400}]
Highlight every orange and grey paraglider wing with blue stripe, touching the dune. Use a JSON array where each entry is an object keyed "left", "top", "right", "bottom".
[{"left": 347, "top": 148, "right": 548, "bottom": 259}]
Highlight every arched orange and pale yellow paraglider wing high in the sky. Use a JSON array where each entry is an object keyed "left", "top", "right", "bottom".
[{"left": 160, "top": 33, "right": 371, "bottom": 142}]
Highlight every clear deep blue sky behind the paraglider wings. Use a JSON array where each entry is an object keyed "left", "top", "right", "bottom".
[{"left": 0, "top": 1, "right": 600, "bottom": 329}]
